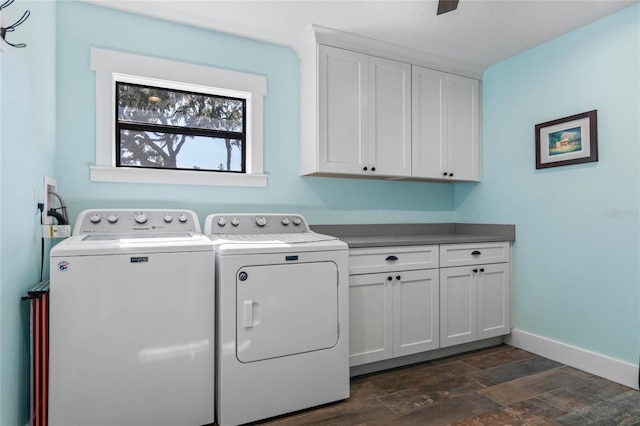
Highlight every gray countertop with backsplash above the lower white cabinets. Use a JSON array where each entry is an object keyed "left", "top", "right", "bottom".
[{"left": 311, "top": 223, "right": 516, "bottom": 248}]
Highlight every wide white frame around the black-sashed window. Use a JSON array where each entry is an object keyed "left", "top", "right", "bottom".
[{"left": 90, "top": 48, "right": 267, "bottom": 187}]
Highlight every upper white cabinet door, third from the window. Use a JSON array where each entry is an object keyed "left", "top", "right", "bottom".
[{"left": 411, "top": 66, "right": 449, "bottom": 179}]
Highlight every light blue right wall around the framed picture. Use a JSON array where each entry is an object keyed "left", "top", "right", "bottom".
[{"left": 455, "top": 5, "right": 640, "bottom": 364}]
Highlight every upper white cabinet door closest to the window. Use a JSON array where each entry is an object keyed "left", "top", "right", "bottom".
[{"left": 318, "top": 46, "right": 369, "bottom": 174}]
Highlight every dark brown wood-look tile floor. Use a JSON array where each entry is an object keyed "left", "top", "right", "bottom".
[{"left": 256, "top": 345, "right": 640, "bottom": 426}]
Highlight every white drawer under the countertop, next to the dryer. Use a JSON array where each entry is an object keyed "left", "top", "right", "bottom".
[{"left": 349, "top": 246, "right": 438, "bottom": 275}]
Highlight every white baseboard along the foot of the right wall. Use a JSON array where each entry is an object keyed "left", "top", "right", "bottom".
[{"left": 504, "top": 329, "right": 638, "bottom": 389}]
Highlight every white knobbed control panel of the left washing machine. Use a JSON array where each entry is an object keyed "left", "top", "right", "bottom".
[{"left": 73, "top": 209, "right": 200, "bottom": 235}]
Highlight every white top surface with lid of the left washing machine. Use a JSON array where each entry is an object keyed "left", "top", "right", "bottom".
[{"left": 51, "top": 232, "right": 213, "bottom": 256}]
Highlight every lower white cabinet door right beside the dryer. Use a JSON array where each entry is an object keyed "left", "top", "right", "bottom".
[{"left": 349, "top": 274, "right": 393, "bottom": 366}]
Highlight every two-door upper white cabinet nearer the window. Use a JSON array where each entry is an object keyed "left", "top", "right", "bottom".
[{"left": 312, "top": 46, "right": 411, "bottom": 177}]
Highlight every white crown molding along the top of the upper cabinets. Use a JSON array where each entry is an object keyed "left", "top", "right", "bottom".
[{"left": 295, "top": 24, "right": 486, "bottom": 80}]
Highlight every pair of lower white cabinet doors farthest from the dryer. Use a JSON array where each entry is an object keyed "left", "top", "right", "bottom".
[{"left": 440, "top": 262, "right": 511, "bottom": 347}]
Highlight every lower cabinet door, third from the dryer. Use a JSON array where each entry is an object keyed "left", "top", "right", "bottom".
[{"left": 440, "top": 266, "right": 478, "bottom": 347}]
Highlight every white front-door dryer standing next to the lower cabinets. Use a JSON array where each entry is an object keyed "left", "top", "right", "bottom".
[{"left": 205, "top": 214, "right": 349, "bottom": 426}]
